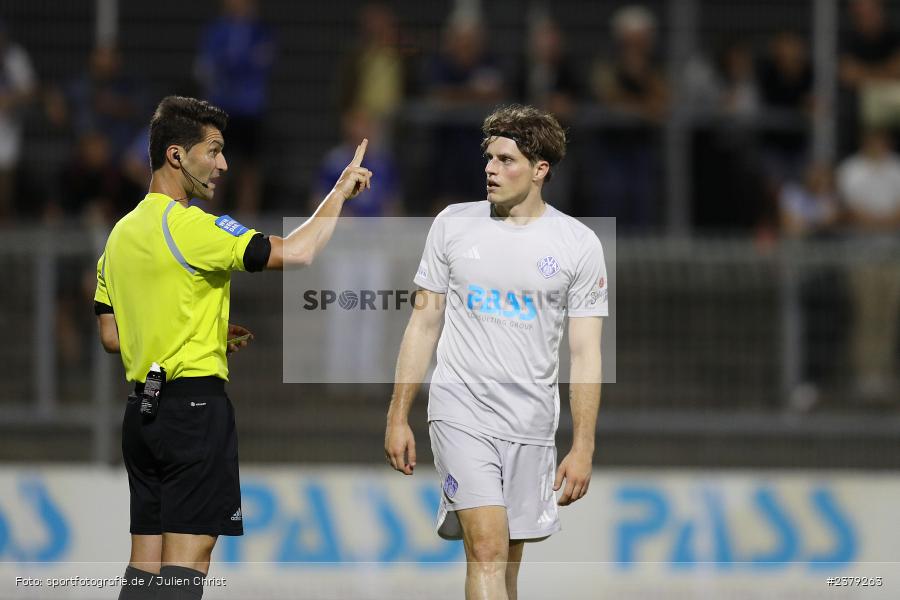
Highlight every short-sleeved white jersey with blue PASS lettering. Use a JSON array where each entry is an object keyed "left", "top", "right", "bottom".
[{"left": 415, "top": 201, "right": 609, "bottom": 445}]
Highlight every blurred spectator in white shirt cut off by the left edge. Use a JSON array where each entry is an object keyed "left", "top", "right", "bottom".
[{"left": 0, "top": 21, "right": 35, "bottom": 222}]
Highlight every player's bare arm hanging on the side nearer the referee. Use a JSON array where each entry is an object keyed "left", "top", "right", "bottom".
[{"left": 384, "top": 289, "right": 446, "bottom": 475}]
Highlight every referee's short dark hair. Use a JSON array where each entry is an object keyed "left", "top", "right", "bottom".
[{"left": 150, "top": 96, "right": 228, "bottom": 171}]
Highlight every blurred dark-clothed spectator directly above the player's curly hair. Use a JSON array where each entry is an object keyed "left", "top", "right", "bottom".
[{"left": 516, "top": 17, "right": 582, "bottom": 122}]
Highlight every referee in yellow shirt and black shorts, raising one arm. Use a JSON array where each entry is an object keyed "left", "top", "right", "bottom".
[{"left": 94, "top": 96, "right": 372, "bottom": 600}]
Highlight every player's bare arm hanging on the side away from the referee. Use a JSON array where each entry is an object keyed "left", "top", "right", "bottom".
[{"left": 553, "top": 317, "right": 603, "bottom": 506}]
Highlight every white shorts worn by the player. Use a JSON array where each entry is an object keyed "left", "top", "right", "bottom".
[{"left": 428, "top": 421, "right": 561, "bottom": 540}]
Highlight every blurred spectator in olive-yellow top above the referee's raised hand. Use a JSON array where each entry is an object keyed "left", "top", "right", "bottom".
[{"left": 339, "top": 3, "right": 412, "bottom": 120}]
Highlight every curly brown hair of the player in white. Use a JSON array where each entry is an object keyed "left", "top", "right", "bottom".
[{"left": 481, "top": 104, "right": 566, "bottom": 181}]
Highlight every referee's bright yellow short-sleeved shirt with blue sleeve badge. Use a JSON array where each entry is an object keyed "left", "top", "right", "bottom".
[{"left": 94, "top": 193, "right": 257, "bottom": 382}]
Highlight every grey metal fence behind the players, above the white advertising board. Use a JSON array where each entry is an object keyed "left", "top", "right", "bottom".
[{"left": 0, "top": 222, "right": 900, "bottom": 466}]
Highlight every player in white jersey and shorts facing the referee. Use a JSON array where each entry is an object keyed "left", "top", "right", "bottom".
[{"left": 385, "top": 106, "right": 608, "bottom": 599}]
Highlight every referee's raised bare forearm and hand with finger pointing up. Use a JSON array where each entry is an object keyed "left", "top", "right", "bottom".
[{"left": 266, "top": 140, "right": 372, "bottom": 269}]
